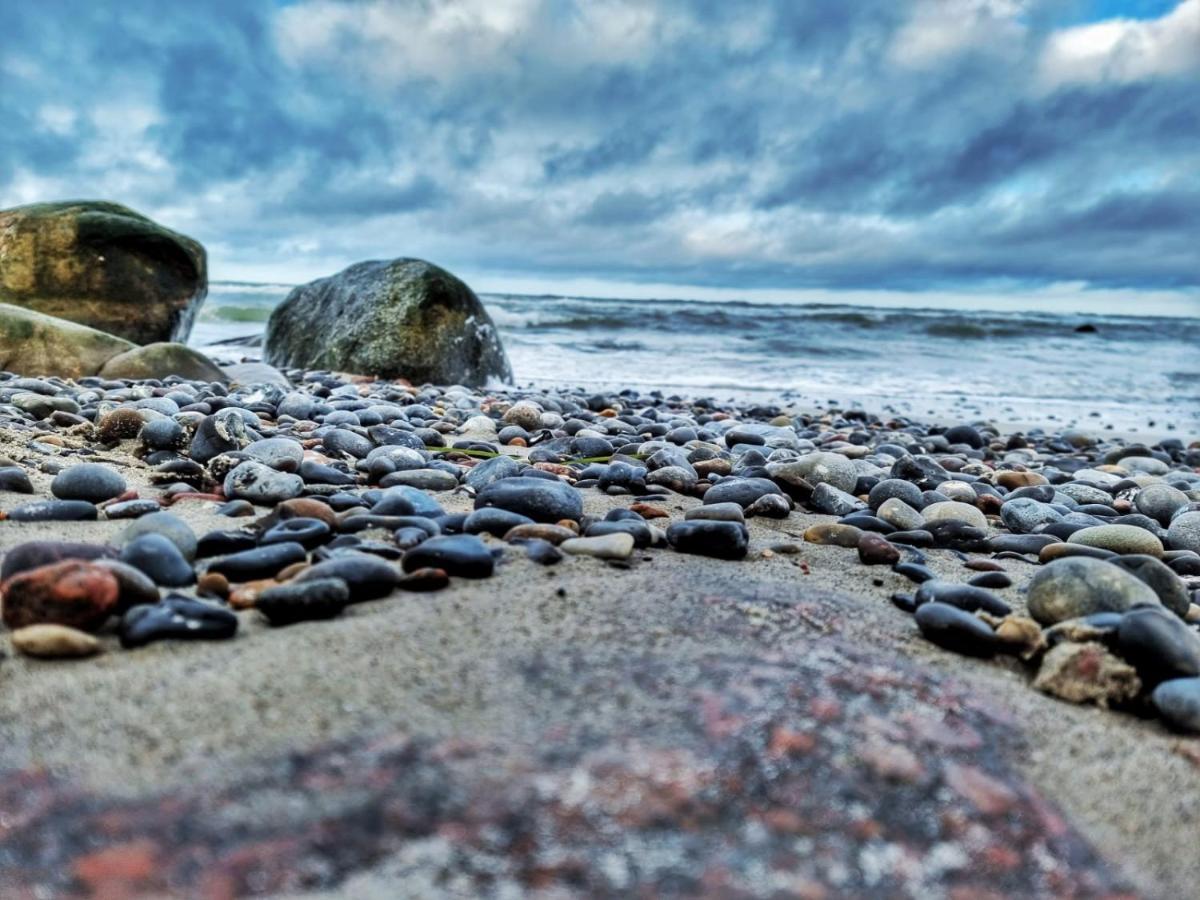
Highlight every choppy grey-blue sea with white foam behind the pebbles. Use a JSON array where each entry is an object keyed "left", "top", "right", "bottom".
[{"left": 191, "top": 282, "right": 1200, "bottom": 442}]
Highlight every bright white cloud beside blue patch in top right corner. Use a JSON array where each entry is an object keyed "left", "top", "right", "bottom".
[{"left": 1038, "top": 0, "right": 1200, "bottom": 88}]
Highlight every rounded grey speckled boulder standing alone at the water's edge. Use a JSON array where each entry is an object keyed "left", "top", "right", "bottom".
[{"left": 264, "top": 259, "right": 512, "bottom": 385}]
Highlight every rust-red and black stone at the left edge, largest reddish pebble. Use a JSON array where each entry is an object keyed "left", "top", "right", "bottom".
[{"left": 0, "top": 559, "right": 120, "bottom": 631}]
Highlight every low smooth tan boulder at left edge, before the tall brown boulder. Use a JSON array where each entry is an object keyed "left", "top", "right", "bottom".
[{"left": 0, "top": 300, "right": 134, "bottom": 378}]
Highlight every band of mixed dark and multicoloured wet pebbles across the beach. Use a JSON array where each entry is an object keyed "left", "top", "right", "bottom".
[{"left": 7, "top": 371, "right": 1200, "bottom": 748}]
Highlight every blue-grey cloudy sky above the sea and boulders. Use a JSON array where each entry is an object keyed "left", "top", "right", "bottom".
[{"left": 0, "top": 0, "right": 1200, "bottom": 311}]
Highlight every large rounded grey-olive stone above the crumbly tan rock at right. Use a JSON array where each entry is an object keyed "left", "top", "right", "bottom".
[{"left": 1026, "top": 557, "right": 1159, "bottom": 625}]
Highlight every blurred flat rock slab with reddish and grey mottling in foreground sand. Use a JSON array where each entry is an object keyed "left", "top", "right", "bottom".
[{"left": 0, "top": 628, "right": 1126, "bottom": 896}]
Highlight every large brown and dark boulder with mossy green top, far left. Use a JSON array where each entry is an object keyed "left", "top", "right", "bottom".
[{"left": 0, "top": 200, "right": 208, "bottom": 343}]
